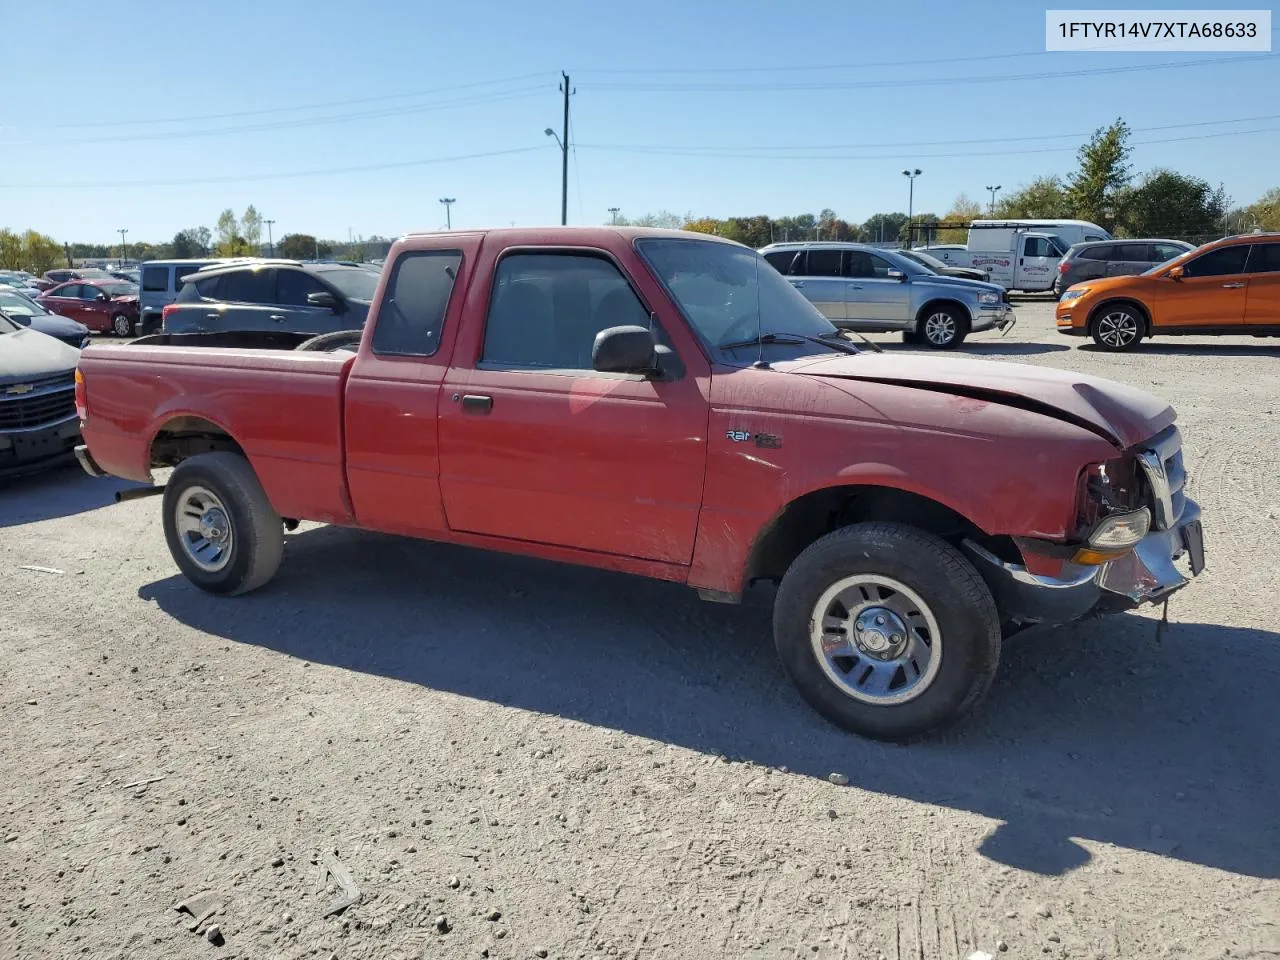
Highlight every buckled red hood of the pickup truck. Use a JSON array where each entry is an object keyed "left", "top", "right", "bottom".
[{"left": 772, "top": 353, "right": 1175, "bottom": 449}]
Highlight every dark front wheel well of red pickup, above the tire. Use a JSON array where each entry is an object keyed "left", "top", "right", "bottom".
[{"left": 744, "top": 485, "right": 1003, "bottom": 584}]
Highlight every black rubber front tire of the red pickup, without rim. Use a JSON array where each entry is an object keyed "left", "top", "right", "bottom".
[{"left": 773, "top": 522, "right": 1001, "bottom": 741}]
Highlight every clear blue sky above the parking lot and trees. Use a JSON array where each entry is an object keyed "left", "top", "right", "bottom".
[{"left": 0, "top": 0, "right": 1280, "bottom": 242}]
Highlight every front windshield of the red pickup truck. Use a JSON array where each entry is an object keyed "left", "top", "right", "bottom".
[{"left": 636, "top": 238, "right": 836, "bottom": 349}]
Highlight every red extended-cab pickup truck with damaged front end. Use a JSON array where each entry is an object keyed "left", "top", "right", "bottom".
[{"left": 77, "top": 228, "right": 1204, "bottom": 740}]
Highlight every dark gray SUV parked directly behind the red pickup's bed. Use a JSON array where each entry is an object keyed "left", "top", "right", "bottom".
[{"left": 164, "top": 260, "right": 378, "bottom": 335}]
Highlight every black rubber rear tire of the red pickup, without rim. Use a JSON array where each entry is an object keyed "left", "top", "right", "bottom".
[{"left": 164, "top": 452, "right": 284, "bottom": 595}]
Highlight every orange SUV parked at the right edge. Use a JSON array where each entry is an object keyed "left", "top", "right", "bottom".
[{"left": 1057, "top": 233, "right": 1280, "bottom": 349}]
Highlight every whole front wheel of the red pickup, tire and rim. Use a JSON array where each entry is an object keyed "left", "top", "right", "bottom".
[{"left": 773, "top": 522, "right": 1001, "bottom": 741}]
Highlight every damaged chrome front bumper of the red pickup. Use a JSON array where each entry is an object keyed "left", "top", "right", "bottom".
[{"left": 964, "top": 499, "right": 1204, "bottom": 625}]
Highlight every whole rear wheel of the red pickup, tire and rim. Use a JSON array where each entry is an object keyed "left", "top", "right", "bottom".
[{"left": 164, "top": 452, "right": 284, "bottom": 594}]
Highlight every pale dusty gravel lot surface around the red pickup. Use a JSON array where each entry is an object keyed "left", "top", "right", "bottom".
[{"left": 0, "top": 308, "right": 1280, "bottom": 960}]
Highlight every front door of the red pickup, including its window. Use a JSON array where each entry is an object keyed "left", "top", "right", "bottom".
[{"left": 439, "top": 248, "right": 708, "bottom": 564}]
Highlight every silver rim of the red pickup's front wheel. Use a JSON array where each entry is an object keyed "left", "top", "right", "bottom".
[{"left": 809, "top": 573, "right": 942, "bottom": 707}]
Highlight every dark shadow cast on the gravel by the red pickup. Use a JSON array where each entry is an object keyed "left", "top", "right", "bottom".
[{"left": 138, "top": 527, "right": 1280, "bottom": 878}]
